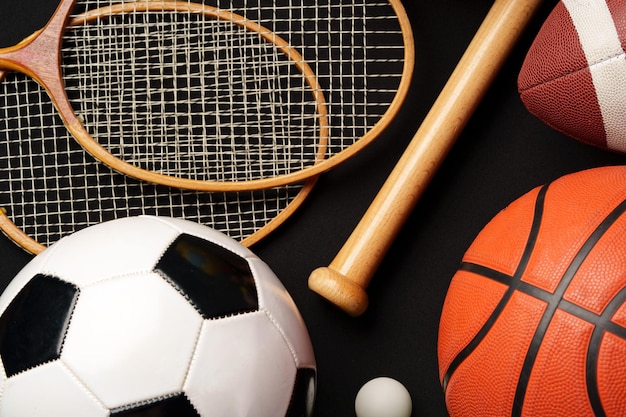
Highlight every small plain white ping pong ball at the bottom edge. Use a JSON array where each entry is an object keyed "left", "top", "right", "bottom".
[{"left": 354, "top": 377, "right": 413, "bottom": 417}]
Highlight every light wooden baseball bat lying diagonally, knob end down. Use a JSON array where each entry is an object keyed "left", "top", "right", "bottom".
[{"left": 309, "top": 0, "right": 541, "bottom": 317}]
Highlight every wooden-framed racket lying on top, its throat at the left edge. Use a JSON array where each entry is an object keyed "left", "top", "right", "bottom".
[{"left": 0, "top": 0, "right": 413, "bottom": 191}]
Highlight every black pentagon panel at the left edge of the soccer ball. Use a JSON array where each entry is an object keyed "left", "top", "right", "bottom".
[{"left": 0, "top": 275, "right": 78, "bottom": 377}]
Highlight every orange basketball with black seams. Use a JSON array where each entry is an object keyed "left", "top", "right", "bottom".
[{"left": 438, "top": 167, "right": 626, "bottom": 417}]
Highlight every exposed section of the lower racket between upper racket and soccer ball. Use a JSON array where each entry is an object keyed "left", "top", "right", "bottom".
[{"left": 0, "top": 72, "right": 316, "bottom": 253}]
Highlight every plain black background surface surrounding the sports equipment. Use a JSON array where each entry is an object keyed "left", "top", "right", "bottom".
[{"left": 0, "top": 0, "right": 626, "bottom": 417}]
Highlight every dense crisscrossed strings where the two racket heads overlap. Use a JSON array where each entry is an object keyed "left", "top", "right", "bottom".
[{"left": 64, "top": 2, "right": 319, "bottom": 181}]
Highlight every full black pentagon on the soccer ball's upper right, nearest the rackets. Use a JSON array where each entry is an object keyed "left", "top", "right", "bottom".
[{"left": 156, "top": 234, "right": 259, "bottom": 319}]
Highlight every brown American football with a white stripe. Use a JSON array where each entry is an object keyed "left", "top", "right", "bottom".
[{"left": 518, "top": 0, "right": 626, "bottom": 152}]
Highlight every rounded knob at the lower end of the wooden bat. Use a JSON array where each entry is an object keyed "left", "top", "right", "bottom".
[{"left": 309, "top": 267, "right": 369, "bottom": 317}]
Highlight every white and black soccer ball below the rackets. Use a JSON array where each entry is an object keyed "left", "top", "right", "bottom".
[{"left": 0, "top": 216, "right": 316, "bottom": 417}]
